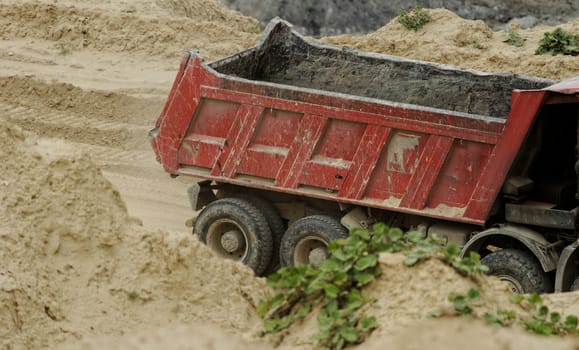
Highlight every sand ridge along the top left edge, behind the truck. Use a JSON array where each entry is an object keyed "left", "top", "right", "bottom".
[{"left": 0, "top": 0, "right": 259, "bottom": 59}]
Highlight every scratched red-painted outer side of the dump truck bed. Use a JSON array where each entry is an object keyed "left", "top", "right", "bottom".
[{"left": 152, "top": 54, "right": 579, "bottom": 224}]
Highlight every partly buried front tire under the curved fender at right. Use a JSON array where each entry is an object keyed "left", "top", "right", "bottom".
[{"left": 481, "top": 249, "right": 552, "bottom": 294}]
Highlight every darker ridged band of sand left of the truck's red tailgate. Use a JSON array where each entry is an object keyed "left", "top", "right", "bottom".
[{"left": 0, "top": 76, "right": 163, "bottom": 151}]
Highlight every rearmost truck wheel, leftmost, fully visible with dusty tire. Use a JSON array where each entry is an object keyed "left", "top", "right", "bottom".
[{"left": 193, "top": 198, "right": 273, "bottom": 276}]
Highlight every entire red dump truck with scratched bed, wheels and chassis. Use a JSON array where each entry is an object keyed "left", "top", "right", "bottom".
[{"left": 149, "top": 19, "right": 579, "bottom": 292}]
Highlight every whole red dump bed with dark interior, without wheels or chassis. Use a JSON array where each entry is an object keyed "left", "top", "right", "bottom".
[{"left": 151, "top": 20, "right": 552, "bottom": 224}]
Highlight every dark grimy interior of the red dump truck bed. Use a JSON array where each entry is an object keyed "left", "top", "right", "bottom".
[{"left": 209, "top": 22, "right": 553, "bottom": 118}]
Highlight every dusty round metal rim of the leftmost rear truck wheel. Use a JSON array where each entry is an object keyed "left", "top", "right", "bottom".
[{"left": 205, "top": 219, "right": 247, "bottom": 260}]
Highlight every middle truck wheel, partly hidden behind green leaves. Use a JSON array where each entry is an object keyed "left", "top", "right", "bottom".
[{"left": 280, "top": 215, "right": 348, "bottom": 266}]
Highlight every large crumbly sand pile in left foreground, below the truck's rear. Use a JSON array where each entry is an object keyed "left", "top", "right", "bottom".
[{"left": 0, "top": 122, "right": 266, "bottom": 349}]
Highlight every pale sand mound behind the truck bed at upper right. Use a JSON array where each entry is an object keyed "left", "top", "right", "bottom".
[{"left": 322, "top": 9, "right": 579, "bottom": 79}]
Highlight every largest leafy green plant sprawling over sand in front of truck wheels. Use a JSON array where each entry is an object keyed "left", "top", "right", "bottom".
[{"left": 257, "top": 223, "right": 494, "bottom": 349}]
